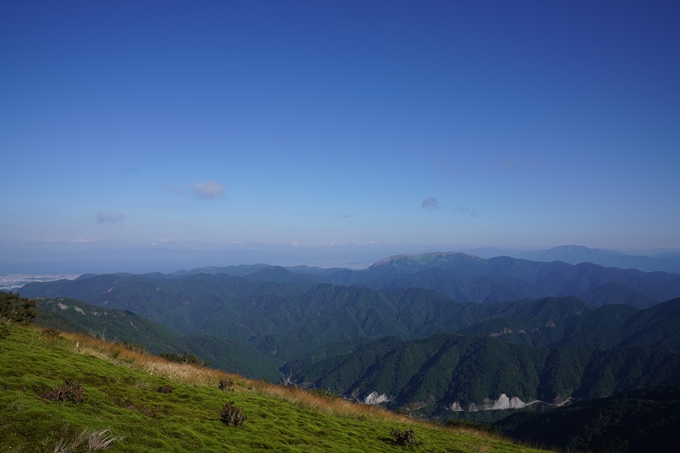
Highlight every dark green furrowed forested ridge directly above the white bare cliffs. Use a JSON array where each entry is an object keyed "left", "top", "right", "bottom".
[{"left": 294, "top": 334, "right": 680, "bottom": 409}]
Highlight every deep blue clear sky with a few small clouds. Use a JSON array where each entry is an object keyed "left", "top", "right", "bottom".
[{"left": 0, "top": 0, "right": 680, "bottom": 272}]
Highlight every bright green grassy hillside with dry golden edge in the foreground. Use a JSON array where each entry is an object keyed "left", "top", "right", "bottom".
[{"left": 0, "top": 326, "right": 537, "bottom": 453}]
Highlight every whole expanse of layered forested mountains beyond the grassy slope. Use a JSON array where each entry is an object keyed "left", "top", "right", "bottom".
[{"left": 14, "top": 253, "right": 680, "bottom": 445}]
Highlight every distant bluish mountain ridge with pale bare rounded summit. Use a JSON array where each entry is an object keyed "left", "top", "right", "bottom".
[{"left": 326, "top": 253, "right": 680, "bottom": 308}]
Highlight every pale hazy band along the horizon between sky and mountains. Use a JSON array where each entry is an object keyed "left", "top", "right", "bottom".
[{"left": 0, "top": 244, "right": 680, "bottom": 274}]
